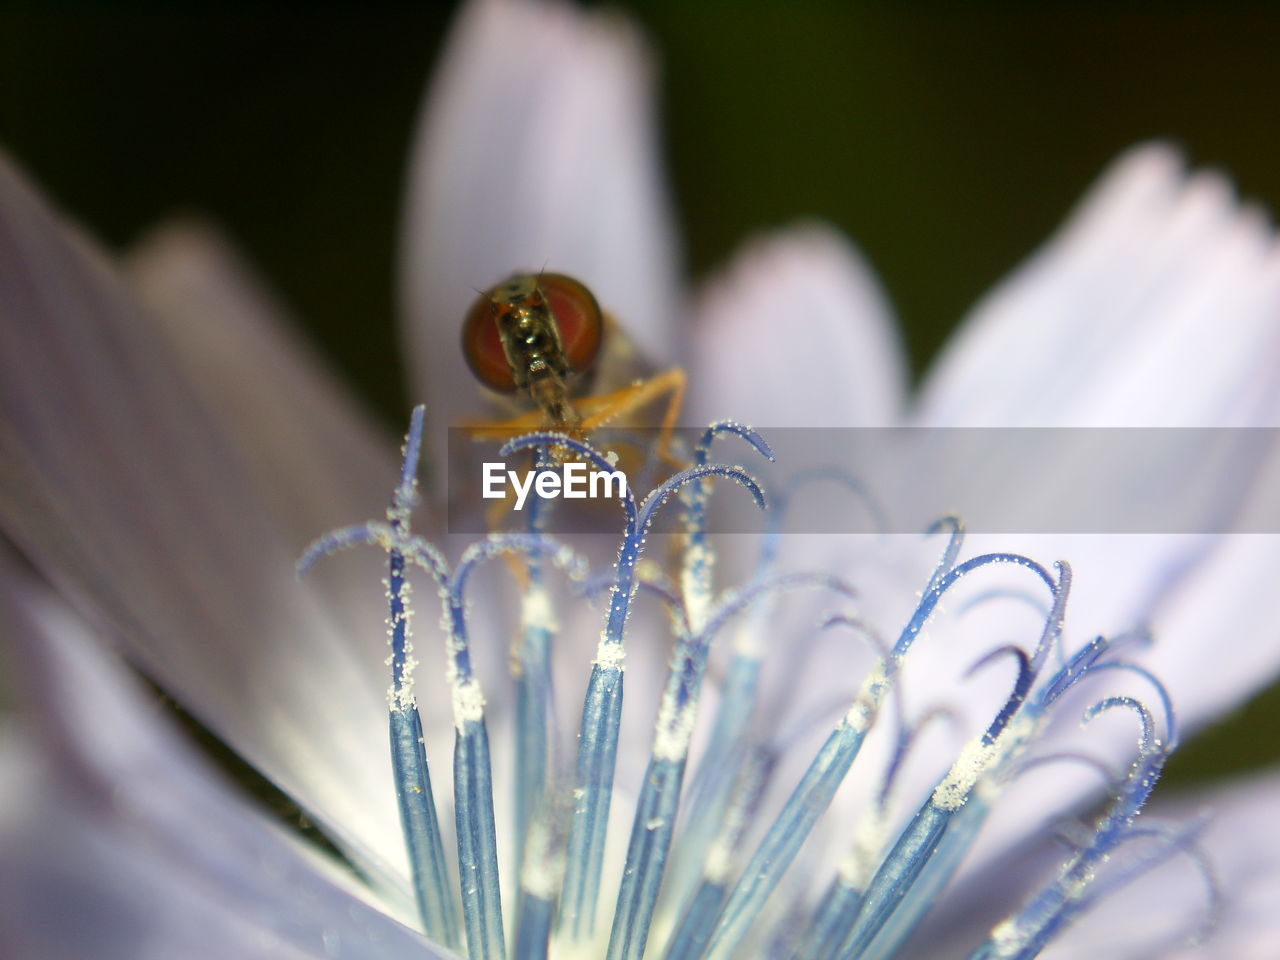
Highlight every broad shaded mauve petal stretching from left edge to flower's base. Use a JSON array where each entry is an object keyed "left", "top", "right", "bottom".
[{"left": 0, "top": 154, "right": 403, "bottom": 890}]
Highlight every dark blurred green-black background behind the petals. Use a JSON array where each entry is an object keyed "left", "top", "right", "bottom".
[{"left": 0, "top": 0, "right": 1280, "bottom": 781}]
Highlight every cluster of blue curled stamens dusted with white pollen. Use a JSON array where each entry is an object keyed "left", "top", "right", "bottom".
[{"left": 300, "top": 407, "right": 1199, "bottom": 960}]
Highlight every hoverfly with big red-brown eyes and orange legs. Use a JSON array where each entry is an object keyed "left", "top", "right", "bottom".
[{"left": 462, "top": 273, "right": 685, "bottom": 463}]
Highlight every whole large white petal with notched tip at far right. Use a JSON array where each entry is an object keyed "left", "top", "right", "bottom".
[{"left": 914, "top": 145, "right": 1280, "bottom": 778}]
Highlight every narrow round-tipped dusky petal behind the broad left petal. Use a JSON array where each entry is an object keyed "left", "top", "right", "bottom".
[{"left": 125, "top": 220, "right": 399, "bottom": 650}]
